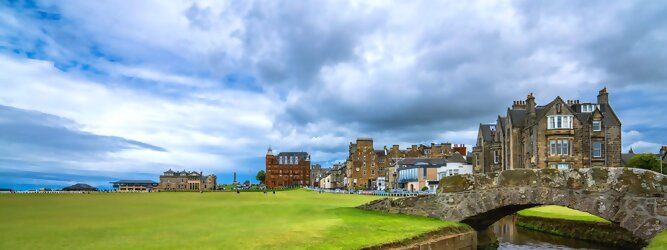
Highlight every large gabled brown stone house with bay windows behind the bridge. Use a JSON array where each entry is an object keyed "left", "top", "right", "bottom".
[{"left": 473, "top": 88, "right": 621, "bottom": 172}]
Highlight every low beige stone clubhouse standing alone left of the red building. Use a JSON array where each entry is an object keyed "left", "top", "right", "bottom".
[{"left": 158, "top": 169, "right": 217, "bottom": 191}]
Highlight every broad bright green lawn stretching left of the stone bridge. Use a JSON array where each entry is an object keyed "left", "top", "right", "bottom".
[{"left": 0, "top": 190, "right": 462, "bottom": 249}]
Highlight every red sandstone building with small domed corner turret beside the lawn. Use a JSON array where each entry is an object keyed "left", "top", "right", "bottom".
[{"left": 265, "top": 147, "right": 310, "bottom": 188}]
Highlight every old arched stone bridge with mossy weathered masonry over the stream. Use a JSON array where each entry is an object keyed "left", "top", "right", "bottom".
[{"left": 360, "top": 168, "right": 667, "bottom": 241}]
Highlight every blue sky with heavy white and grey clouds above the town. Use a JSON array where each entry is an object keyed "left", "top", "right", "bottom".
[{"left": 0, "top": 0, "right": 667, "bottom": 189}]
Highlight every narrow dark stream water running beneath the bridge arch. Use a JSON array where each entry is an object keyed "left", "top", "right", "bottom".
[{"left": 488, "top": 215, "right": 622, "bottom": 250}]
